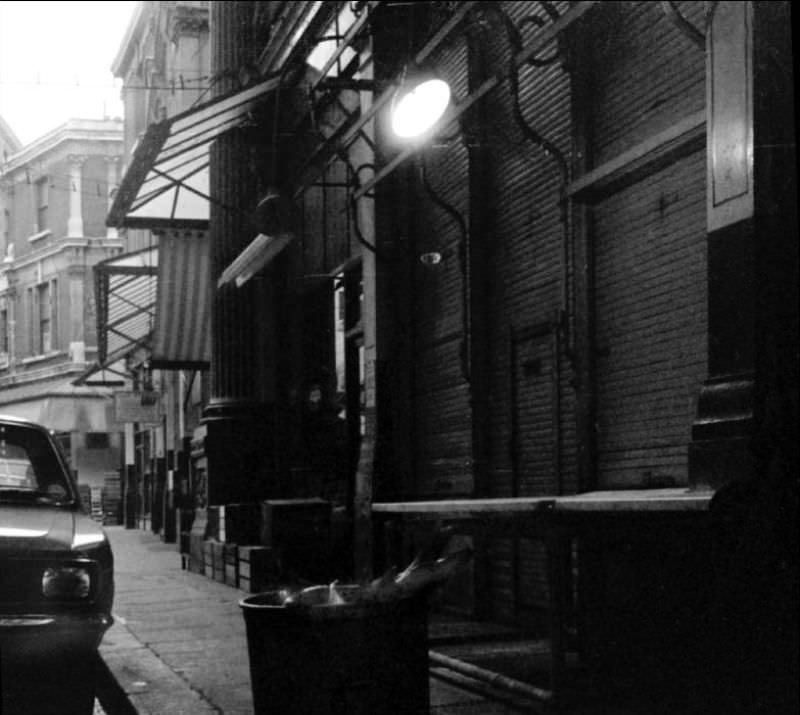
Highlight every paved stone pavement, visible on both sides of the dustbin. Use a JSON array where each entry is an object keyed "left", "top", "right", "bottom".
[{"left": 97, "top": 526, "right": 540, "bottom": 715}]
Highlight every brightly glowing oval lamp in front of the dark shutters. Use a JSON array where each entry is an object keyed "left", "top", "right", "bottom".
[{"left": 391, "top": 64, "right": 452, "bottom": 139}]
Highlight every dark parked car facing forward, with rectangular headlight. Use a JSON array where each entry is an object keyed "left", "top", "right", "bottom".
[{"left": 0, "top": 416, "right": 114, "bottom": 715}]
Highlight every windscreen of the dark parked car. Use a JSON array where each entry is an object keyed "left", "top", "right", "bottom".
[{"left": 0, "top": 424, "right": 74, "bottom": 505}]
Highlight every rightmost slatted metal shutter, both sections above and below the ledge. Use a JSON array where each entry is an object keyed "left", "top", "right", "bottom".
[{"left": 589, "top": 2, "right": 706, "bottom": 488}]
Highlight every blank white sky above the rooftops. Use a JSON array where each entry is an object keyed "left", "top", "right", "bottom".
[{"left": 0, "top": 0, "right": 136, "bottom": 144}]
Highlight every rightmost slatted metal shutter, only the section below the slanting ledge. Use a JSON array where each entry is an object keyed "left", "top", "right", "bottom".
[{"left": 594, "top": 152, "right": 706, "bottom": 488}]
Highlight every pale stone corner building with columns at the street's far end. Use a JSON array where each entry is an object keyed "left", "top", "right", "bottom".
[{"left": 0, "top": 119, "right": 123, "bottom": 499}]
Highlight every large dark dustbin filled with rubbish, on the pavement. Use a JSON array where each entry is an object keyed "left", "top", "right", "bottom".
[{"left": 239, "top": 586, "right": 430, "bottom": 715}]
